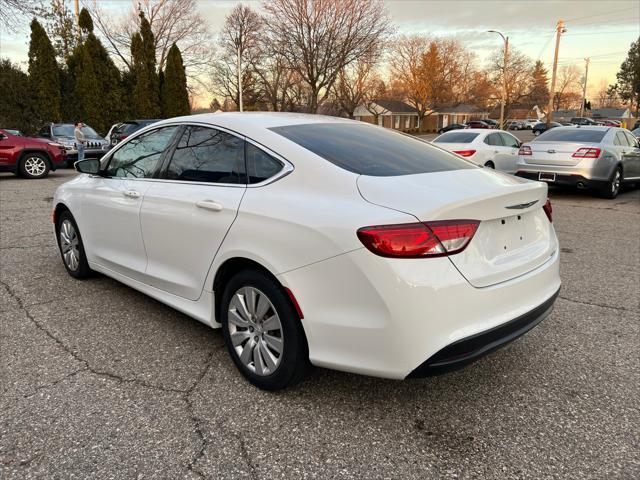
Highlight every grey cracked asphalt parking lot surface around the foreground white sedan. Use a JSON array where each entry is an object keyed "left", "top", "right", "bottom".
[{"left": 0, "top": 170, "right": 640, "bottom": 480}]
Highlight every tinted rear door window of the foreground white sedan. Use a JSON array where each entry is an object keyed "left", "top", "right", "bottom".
[{"left": 166, "top": 126, "right": 244, "bottom": 183}]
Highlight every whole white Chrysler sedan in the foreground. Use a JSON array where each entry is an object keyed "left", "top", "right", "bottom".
[{"left": 53, "top": 113, "right": 560, "bottom": 390}]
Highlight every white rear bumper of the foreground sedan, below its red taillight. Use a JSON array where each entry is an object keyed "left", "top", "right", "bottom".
[{"left": 278, "top": 242, "right": 560, "bottom": 379}]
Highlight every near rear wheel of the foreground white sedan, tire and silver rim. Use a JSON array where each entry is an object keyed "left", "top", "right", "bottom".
[{"left": 220, "top": 270, "right": 311, "bottom": 391}]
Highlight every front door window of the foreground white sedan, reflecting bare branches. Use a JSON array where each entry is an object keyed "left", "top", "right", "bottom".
[{"left": 105, "top": 126, "right": 179, "bottom": 178}]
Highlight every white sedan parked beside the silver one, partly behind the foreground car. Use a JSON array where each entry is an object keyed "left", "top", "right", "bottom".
[{"left": 433, "top": 128, "right": 520, "bottom": 173}]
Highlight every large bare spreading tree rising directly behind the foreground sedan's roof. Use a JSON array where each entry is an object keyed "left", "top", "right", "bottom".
[{"left": 263, "top": 0, "right": 391, "bottom": 112}]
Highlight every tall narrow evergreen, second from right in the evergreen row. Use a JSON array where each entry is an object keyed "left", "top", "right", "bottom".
[{"left": 131, "top": 12, "right": 160, "bottom": 118}]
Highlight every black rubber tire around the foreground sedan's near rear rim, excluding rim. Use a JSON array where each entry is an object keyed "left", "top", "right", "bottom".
[{"left": 220, "top": 270, "right": 309, "bottom": 390}]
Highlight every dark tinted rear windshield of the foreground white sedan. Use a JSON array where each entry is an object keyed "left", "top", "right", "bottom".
[{"left": 271, "top": 123, "right": 475, "bottom": 177}]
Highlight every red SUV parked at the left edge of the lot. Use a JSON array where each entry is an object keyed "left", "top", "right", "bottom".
[{"left": 0, "top": 128, "right": 67, "bottom": 178}]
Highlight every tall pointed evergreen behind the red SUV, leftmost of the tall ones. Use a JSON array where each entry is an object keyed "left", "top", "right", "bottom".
[{"left": 29, "top": 18, "right": 61, "bottom": 122}]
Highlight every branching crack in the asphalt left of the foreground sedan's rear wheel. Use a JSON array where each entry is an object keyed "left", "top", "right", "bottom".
[{"left": 0, "top": 280, "right": 226, "bottom": 478}]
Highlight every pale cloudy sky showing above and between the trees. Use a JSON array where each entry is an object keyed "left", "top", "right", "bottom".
[{"left": 0, "top": 0, "right": 640, "bottom": 107}]
